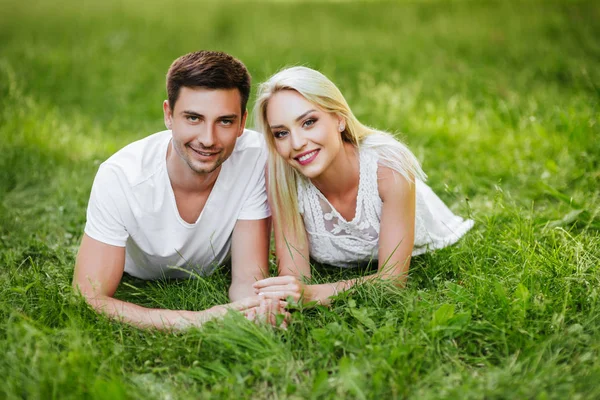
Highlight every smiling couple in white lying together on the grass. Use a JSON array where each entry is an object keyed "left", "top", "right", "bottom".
[{"left": 73, "top": 51, "right": 473, "bottom": 329}]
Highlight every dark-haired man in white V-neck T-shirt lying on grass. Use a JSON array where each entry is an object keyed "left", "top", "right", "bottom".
[{"left": 73, "top": 51, "right": 279, "bottom": 329}]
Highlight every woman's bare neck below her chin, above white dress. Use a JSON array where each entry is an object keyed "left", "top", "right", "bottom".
[{"left": 311, "top": 142, "right": 360, "bottom": 198}]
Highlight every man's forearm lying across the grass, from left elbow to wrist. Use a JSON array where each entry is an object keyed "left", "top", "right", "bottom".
[{"left": 85, "top": 295, "right": 219, "bottom": 330}]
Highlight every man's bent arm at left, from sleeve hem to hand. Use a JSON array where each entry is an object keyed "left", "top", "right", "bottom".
[{"left": 73, "top": 234, "right": 260, "bottom": 330}]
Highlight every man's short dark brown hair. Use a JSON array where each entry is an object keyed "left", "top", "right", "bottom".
[{"left": 167, "top": 50, "right": 251, "bottom": 114}]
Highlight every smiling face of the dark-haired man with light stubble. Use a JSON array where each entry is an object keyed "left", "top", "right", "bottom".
[{"left": 163, "top": 87, "right": 248, "bottom": 174}]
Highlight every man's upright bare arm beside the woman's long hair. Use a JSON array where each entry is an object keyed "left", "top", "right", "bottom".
[{"left": 229, "top": 218, "right": 271, "bottom": 301}]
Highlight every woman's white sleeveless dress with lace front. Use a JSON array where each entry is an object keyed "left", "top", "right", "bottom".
[{"left": 298, "top": 136, "right": 473, "bottom": 267}]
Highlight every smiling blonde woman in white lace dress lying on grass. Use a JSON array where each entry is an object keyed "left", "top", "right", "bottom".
[{"left": 254, "top": 67, "right": 473, "bottom": 304}]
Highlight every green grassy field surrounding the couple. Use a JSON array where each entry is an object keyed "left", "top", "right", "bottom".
[{"left": 0, "top": 0, "right": 600, "bottom": 399}]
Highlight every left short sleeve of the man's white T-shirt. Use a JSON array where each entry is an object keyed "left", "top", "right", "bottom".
[{"left": 85, "top": 165, "right": 129, "bottom": 247}]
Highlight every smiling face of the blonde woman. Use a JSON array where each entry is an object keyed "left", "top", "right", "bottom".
[{"left": 267, "top": 90, "right": 343, "bottom": 179}]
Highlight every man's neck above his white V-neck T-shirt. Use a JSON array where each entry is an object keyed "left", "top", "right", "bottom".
[{"left": 167, "top": 143, "right": 221, "bottom": 193}]
